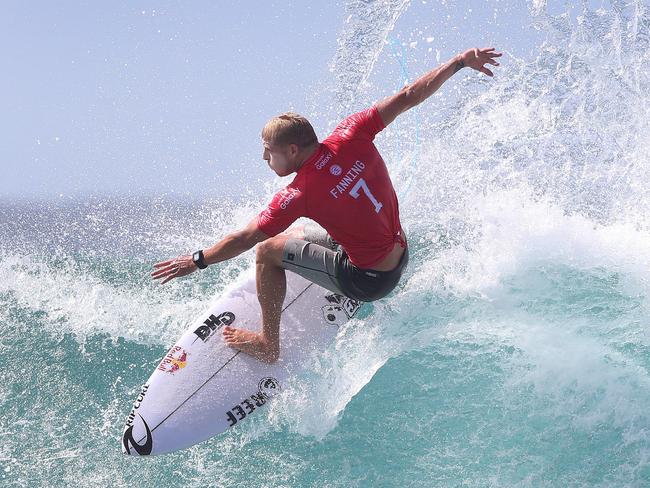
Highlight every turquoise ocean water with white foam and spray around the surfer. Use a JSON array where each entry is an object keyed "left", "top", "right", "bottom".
[{"left": 0, "top": 1, "right": 650, "bottom": 488}]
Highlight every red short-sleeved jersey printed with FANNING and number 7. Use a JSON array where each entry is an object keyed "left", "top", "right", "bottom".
[{"left": 257, "top": 107, "right": 406, "bottom": 268}]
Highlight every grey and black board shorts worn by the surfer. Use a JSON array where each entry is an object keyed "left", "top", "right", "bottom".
[{"left": 282, "top": 224, "right": 409, "bottom": 302}]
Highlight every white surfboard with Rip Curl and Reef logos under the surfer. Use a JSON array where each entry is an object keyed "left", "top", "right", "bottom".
[{"left": 122, "top": 269, "right": 361, "bottom": 456}]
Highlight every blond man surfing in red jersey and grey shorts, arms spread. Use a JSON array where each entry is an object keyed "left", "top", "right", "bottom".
[{"left": 152, "top": 48, "right": 501, "bottom": 362}]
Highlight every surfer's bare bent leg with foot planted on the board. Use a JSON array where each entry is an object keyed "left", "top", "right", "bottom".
[{"left": 223, "top": 227, "right": 303, "bottom": 363}]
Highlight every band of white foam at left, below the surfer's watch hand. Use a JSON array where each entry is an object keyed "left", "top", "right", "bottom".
[{"left": 0, "top": 255, "right": 251, "bottom": 345}]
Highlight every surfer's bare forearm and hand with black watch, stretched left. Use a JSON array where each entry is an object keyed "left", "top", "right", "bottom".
[{"left": 151, "top": 218, "right": 269, "bottom": 285}]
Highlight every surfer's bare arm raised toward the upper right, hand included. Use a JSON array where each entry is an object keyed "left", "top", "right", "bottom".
[{"left": 377, "top": 47, "right": 501, "bottom": 125}]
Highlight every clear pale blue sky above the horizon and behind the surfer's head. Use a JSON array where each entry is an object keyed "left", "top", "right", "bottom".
[{"left": 0, "top": 0, "right": 556, "bottom": 199}]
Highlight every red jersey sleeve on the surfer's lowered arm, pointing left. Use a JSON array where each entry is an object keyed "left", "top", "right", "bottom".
[{"left": 257, "top": 185, "right": 306, "bottom": 237}]
